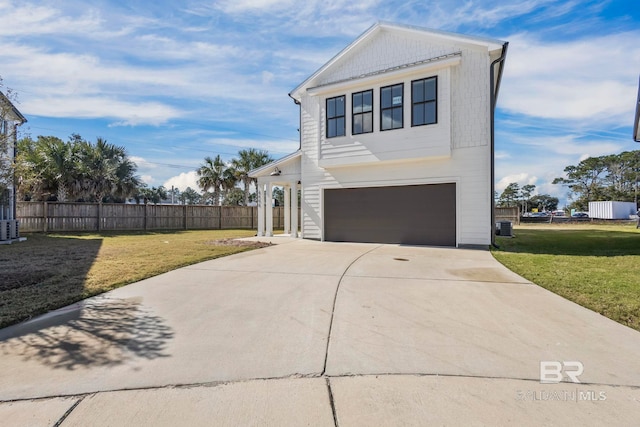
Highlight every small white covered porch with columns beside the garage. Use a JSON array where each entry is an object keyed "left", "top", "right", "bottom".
[{"left": 249, "top": 151, "right": 302, "bottom": 238}]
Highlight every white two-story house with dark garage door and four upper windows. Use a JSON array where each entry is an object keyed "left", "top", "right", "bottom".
[{"left": 251, "top": 23, "right": 508, "bottom": 246}]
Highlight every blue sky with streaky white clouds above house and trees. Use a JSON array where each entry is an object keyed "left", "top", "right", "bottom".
[{"left": 0, "top": 0, "right": 640, "bottom": 207}]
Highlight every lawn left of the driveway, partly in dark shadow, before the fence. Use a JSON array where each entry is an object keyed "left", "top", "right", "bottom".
[{"left": 0, "top": 230, "right": 255, "bottom": 327}]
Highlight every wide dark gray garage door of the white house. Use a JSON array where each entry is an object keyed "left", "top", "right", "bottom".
[{"left": 324, "top": 184, "right": 456, "bottom": 246}]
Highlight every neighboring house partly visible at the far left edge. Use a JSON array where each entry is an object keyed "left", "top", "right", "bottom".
[{"left": 0, "top": 92, "right": 27, "bottom": 242}]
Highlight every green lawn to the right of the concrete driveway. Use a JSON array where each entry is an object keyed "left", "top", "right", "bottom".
[{"left": 492, "top": 224, "right": 640, "bottom": 331}]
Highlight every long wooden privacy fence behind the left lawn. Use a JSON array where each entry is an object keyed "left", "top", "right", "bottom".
[{"left": 17, "top": 202, "right": 284, "bottom": 233}]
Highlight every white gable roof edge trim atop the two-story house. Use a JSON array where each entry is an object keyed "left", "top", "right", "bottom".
[{"left": 289, "top": 21, "right": 506, "bottom": 101}]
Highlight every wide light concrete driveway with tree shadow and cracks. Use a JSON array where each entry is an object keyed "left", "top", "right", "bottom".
[{"left": 0, "top": 238, "right": 640, "bottom": 426}]
